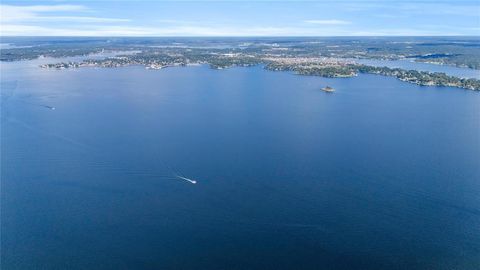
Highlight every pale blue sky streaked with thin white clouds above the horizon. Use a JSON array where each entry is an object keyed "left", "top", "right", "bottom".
[{"left": 0, "top": 0, "right": 480, "bottom": 36}]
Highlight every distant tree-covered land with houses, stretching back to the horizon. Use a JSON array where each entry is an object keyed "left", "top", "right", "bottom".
[{"left": 0, "top": 37, "right": 480, "bottom": 91}]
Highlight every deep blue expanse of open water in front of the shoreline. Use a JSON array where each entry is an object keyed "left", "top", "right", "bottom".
[{"left": 1, "top": 61, "right": 480, "bottom": 269}]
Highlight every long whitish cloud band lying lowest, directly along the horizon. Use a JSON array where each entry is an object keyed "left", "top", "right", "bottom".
[{"left": 0, "top": 24, "right": 478, "bottom": 37}]
